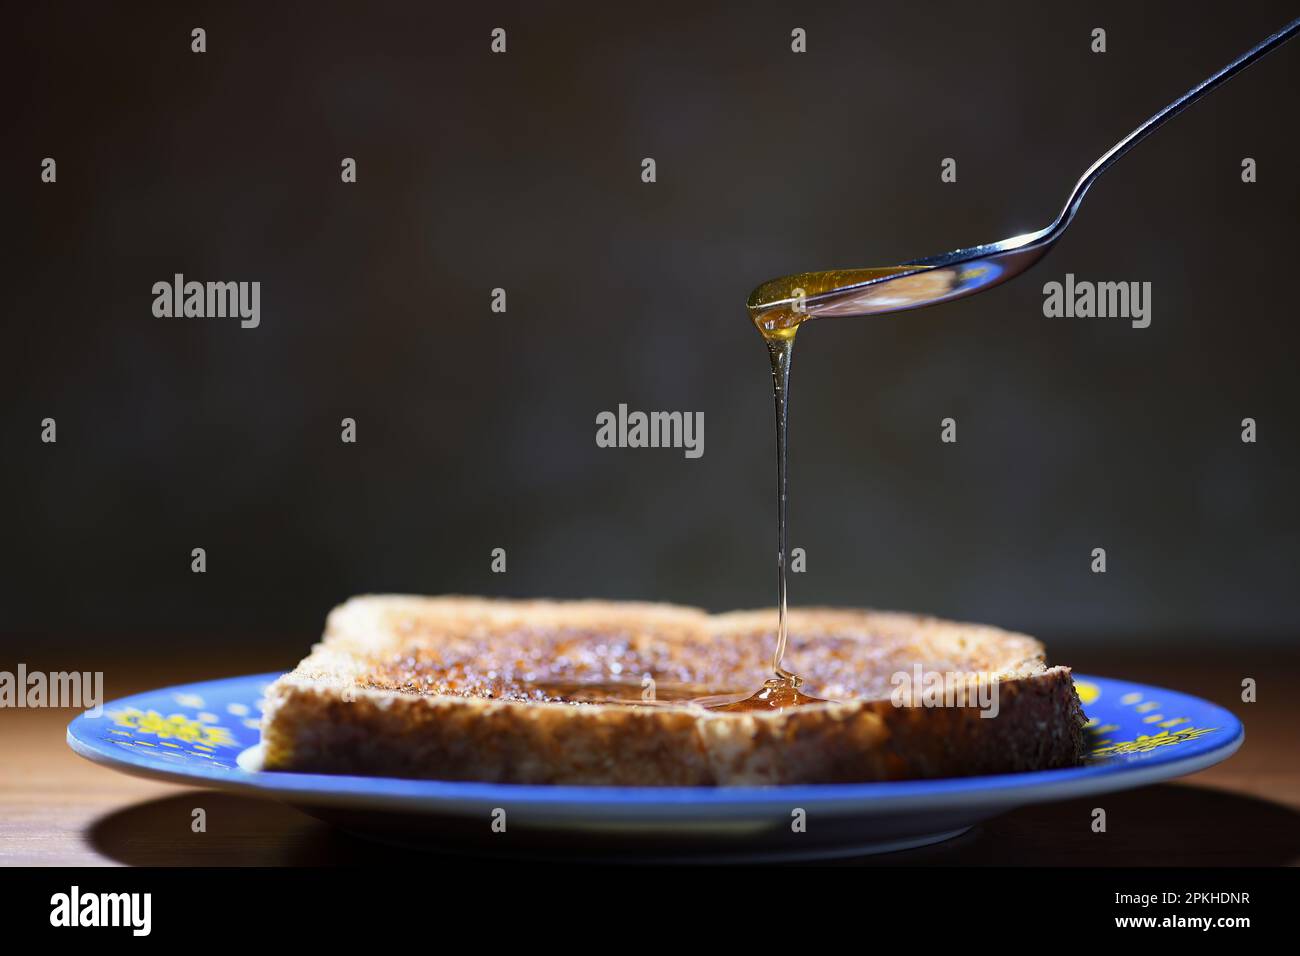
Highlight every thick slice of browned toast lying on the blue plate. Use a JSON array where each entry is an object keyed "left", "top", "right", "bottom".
[{"left": 263, "top": 596, "right": 1084, "bottom": 786}]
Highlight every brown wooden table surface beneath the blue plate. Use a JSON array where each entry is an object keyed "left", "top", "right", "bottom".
[{"left": 0, "top": 650, "right": 1300, "bottom": 866}]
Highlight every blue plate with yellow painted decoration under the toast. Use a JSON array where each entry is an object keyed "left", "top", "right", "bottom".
[{"left": 68, "top": 674, "right": 1245, "bottom": 858}]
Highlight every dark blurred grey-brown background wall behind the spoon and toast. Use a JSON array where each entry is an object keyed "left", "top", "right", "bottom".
[{"left": 0, "top": 0, "right": 1300, "bottom": 670}]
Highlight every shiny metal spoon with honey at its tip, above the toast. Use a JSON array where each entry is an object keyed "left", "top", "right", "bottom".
[{"left": 749, "top": 10, "right": 1300, "bottom": 338}]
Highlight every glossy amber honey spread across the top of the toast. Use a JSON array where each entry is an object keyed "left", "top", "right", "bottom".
[{"left": 366, "top": 617, "right": 917, "bottom": 713}]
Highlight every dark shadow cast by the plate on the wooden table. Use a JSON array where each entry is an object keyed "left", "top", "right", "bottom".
[{"left": 87, "top": 784, "right": 1300, "bottom": 866}]
